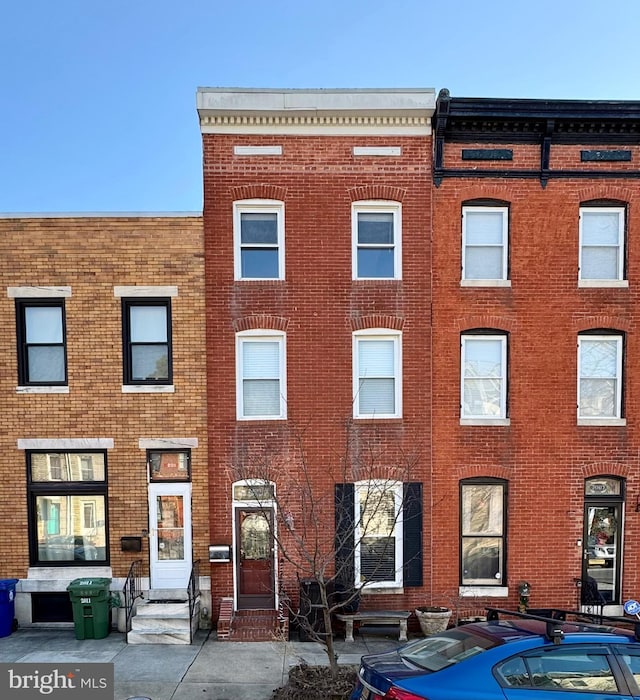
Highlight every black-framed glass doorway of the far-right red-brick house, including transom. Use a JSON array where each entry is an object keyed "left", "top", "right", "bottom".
[{"left": 582, "top": 477, "right": 623, "bottom": 605}]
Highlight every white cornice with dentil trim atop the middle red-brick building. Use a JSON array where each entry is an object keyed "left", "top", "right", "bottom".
[{"left": 197, "top": 88, "right": 435, "bottom": 136}]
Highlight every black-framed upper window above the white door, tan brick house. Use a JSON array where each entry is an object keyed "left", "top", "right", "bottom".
[{"left": 122, "top": 298, "right": 173, "bottom": 384}]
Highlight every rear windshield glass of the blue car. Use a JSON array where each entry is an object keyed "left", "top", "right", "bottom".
[{"left": 399, "top": 627, "right": 501, "bottom": 671}]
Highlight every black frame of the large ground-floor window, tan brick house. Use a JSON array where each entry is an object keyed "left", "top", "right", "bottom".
[{"left": 25, "top": 449, "right": 110, "bottom": 568}]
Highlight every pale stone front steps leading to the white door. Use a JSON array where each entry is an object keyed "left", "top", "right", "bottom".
[{"left": 127, "top": 598, "right": 200, "bottom": 644}]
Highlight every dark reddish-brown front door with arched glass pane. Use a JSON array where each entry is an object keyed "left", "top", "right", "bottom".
[{"left": 236, "top": 508, "right": 275, "bottom": 610}]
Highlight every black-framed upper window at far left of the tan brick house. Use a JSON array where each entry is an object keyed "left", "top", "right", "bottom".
[{"left": 16, "top": 299, "right": 67, "bottom": 386}]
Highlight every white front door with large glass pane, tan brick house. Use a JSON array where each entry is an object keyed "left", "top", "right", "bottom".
[{"left": 149, "top": 483, "right": 193, "bottom": 589}]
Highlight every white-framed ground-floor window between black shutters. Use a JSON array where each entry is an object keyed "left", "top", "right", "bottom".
[{"left": 355, "top": 480, "right": 403, "bottom": 588}]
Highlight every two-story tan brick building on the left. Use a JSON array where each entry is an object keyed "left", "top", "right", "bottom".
[{"left": 0, "top": 215, "right": 209, "bottom": 625}]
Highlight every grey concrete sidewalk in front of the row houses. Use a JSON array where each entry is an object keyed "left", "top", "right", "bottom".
[{"left": 0, "top": 628, "right": 399, "bottom": 700}]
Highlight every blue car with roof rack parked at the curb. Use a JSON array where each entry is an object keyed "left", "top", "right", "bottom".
[{"left": 351, "top": 609, "right": 640, "bottom": 700}]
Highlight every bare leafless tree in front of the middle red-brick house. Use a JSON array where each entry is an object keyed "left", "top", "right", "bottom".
[{"left": 230, "top": 420, "right": 422, "bottom": 677}]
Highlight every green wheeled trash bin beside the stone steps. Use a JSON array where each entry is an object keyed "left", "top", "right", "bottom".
[{"left": 67, "top": 577, "right": 112, "bottom": 639}]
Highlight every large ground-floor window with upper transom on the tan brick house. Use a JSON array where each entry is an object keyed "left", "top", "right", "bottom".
[{"left": 27, "top": 451, "right": 108, "bottom": 566}]
